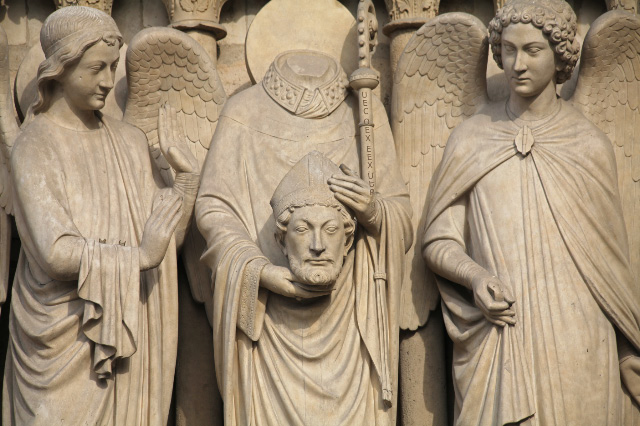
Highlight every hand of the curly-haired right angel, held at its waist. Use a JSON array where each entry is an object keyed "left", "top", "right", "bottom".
[{"left": 471, "top": 276, "right": 516, "bottom": 327}]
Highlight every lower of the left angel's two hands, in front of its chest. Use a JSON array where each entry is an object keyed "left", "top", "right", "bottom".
[{"left": 140, "top": 192, "right": 182, "bottom": 271}]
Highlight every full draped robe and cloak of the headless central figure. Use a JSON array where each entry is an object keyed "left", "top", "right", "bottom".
[{"left": 196, "top": 85, "right": 411, "bottom": 426}]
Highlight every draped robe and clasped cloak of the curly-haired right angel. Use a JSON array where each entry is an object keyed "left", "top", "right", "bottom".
[{"left": 423, "top": 101, "right": 640, "bottom": 426}]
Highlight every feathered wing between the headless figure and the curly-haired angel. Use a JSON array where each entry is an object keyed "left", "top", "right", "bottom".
[{"left": 391, "top": 12, "right": 489, "bottom": 330}]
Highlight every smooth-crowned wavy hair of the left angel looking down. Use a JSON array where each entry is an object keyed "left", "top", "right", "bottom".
[{"left": 28, "top": 6, "right": 122, "bottom": 116}]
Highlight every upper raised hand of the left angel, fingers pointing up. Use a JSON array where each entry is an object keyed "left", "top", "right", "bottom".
[{"left": 158, "top": 104, "right": 200, "bottom": 173}]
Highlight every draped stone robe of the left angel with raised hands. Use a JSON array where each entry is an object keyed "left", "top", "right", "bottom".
[{"left": 3, "top": 115, "right": 177, "bottom": 426}]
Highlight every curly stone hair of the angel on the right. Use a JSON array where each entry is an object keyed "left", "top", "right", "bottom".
[{"left": 489, "top": 0, "right": 580, "bottom": 84}]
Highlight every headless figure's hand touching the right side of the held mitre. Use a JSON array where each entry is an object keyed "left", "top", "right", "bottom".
[{"left": 328, "top": 164, "right": 382, "bottom": 235}]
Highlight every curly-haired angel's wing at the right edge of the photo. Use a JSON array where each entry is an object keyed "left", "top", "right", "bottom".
[{"left": 572, "top": 10, "right": 640, "bottom": 283}]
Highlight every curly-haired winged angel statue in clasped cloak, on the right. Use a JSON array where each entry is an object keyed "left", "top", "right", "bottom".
[{"left": 395, "top": 0, "right": 640, "bottom": 425}]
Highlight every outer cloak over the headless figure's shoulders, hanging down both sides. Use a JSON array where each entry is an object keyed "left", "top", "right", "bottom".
[{"left": 196, "top": 81, "right": 412, "bottom": 425}]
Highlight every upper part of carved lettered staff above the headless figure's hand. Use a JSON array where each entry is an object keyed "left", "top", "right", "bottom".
[{"left": 349, "top": 0, "right": 380, "bottom": 195}]
